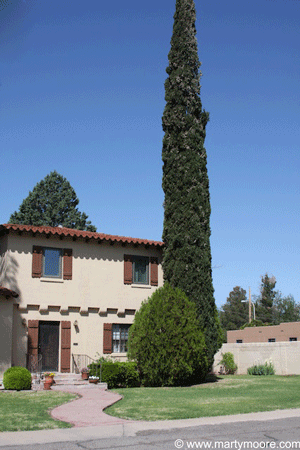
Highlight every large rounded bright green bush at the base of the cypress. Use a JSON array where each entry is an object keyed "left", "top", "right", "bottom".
[{"left": 128, "top": 283, "right": 208, "bottom": 386}]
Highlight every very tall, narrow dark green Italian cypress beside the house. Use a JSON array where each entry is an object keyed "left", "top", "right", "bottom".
[{"left": 162, "top": 0, "right": 220, "bottom": 362}]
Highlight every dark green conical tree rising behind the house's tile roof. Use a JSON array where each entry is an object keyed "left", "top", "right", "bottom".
[{"left": 9, "top": 171, "right": 96, "bottom": 231}]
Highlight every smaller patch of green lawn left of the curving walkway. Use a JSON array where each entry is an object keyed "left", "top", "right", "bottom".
[{"left": 0, "top": 391, "right": 77, "bottom": 432}]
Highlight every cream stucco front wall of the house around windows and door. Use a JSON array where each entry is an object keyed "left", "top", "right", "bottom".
[{"left": 2, "top": 234, "right": 163, "bottom": 372}]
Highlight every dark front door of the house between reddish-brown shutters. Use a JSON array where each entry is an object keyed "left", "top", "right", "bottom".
[{"left": 39, "top": 321, "right": 59, "bottom": 372}]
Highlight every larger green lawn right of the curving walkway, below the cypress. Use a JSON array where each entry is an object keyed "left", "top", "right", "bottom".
[{"left": 105, "top": 375, "right": 300, "bottom": 420}]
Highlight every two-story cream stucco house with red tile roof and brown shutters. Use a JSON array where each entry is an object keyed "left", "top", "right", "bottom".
[{"left": 0, "top": 224, "right": 163, "bottom": 375}]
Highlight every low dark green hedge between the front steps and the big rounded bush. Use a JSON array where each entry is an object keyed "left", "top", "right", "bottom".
[{"left": 89, "top": 358, "right": 140, "bottom": 389}]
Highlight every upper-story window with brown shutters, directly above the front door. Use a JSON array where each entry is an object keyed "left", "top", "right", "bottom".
[{"left": 32, "top": 245, "right": 73, "bottom": 280}]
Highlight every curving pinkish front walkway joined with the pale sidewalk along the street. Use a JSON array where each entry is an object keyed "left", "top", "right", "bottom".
[{"left": 0, "top": 386, "right": 300, "bottom": 448}]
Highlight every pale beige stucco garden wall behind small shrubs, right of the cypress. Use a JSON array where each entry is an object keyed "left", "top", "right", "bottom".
[{"left": 213, "top": 342, "right": 300, "bottom": 375}]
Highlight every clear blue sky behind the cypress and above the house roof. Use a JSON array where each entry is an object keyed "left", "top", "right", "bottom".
[{"left": 0, "top": 0, "right": 300, "bottom": 307}]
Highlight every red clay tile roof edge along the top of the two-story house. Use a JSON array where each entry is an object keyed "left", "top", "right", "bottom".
[{"left": 0, "top": 223, "right": 163, "bottom": 247}]
